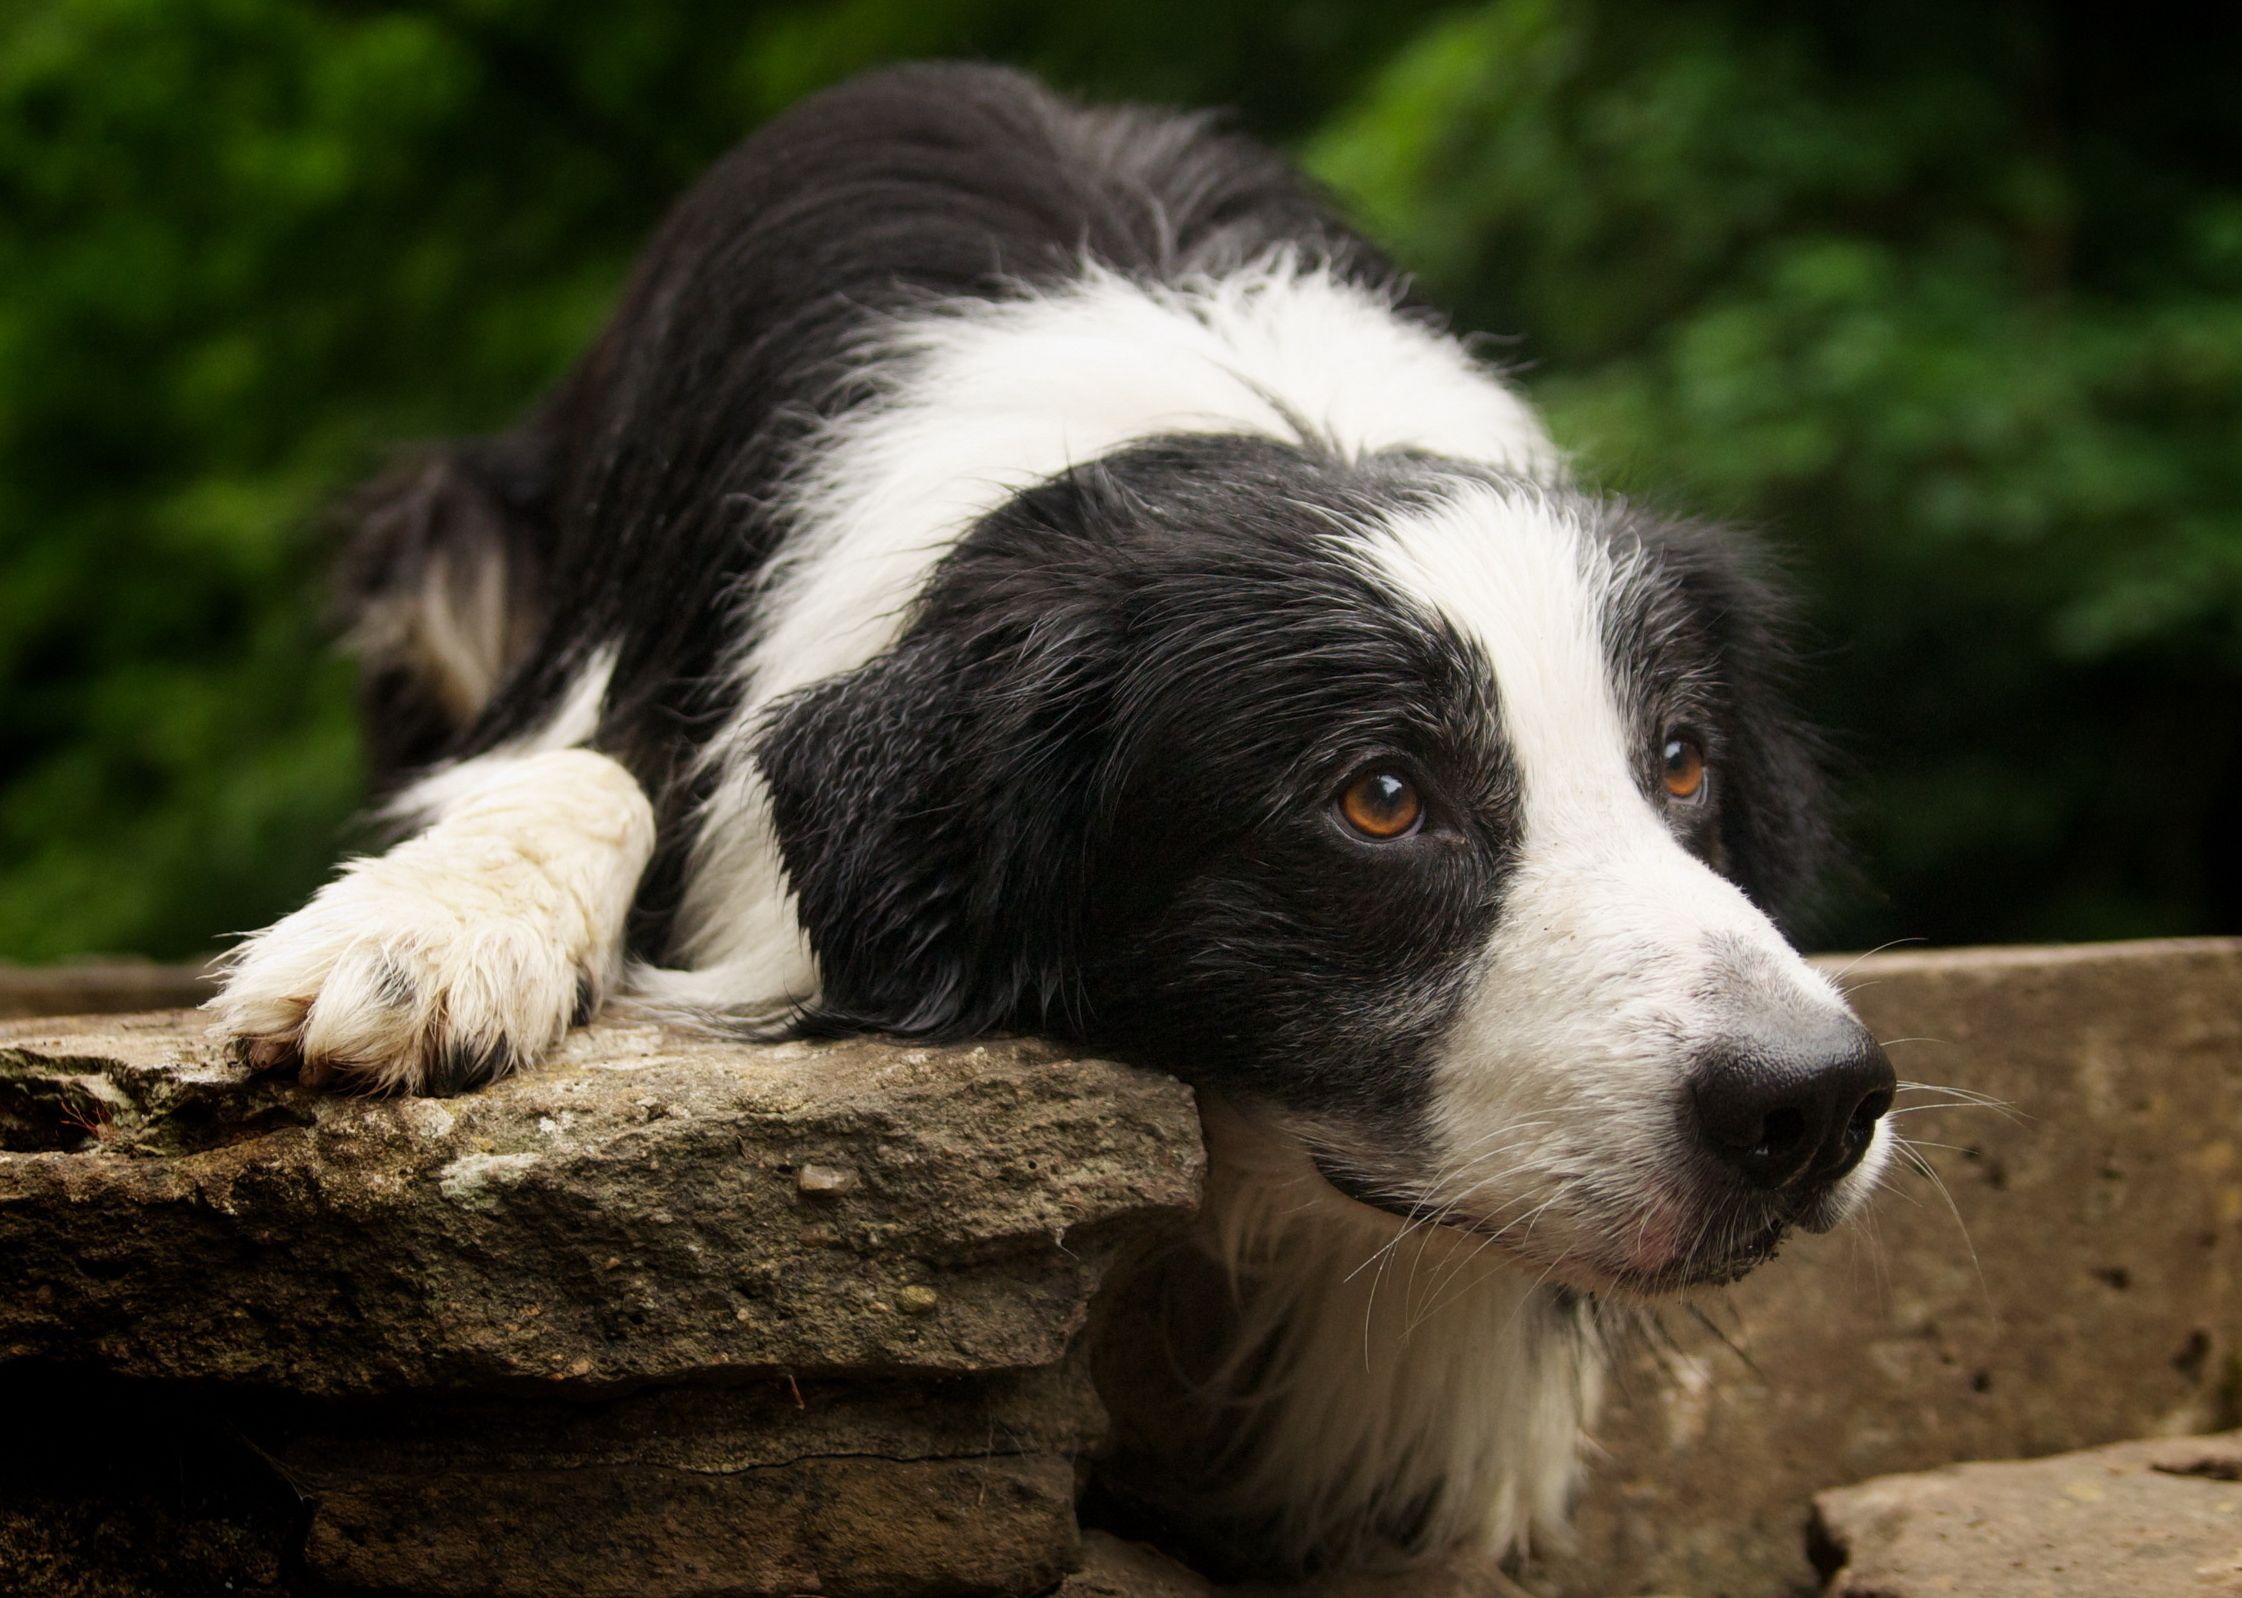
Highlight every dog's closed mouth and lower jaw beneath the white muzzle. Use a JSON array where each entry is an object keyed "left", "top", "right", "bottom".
[{"left": 1314, "top": 1156, "right": 1841, "bottom": 1295}]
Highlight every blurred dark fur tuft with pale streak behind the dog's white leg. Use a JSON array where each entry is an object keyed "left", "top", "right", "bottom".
[{"left": 341, "top": 430, "right": 556, "bottom": 791}]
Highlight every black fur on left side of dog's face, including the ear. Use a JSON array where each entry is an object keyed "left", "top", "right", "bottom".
[{"left": 760, "top": 437, "right": 1513, "bottom": 1134}]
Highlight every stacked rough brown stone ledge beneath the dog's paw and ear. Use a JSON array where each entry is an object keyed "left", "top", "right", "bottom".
[{"left": 0, "top": 1013, "right": 1202, "bottom": 1598}]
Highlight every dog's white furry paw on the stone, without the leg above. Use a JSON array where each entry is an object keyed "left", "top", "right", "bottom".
[{"left": 209, "top": 845, "right": 605, "bottom": 1094}]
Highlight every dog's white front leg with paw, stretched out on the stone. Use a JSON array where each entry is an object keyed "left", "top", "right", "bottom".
[{"left": 211, "top": 749, "right": 655, "bottom": 1094}]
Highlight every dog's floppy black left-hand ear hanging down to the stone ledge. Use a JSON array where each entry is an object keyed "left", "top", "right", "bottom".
[{"left": 756, "top": 605, "right": 1108, "bottom": 1038}]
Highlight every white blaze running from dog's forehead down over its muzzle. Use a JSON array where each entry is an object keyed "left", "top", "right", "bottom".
[{"left": 1370, "top": 486, "right": 1890, "bottom": 1286}]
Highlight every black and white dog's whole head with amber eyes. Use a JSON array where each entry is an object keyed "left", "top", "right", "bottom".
[{"left": 760, "top": 437, "right": 1892, "bottom": 1289}]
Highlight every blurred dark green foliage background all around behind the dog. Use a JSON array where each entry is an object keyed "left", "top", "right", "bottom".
[{"left": 0, "top": 0, "right": 2242, "bottom": 959}]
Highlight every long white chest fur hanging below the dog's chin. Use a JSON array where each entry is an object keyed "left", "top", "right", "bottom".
[{"left": 1202, "top": 1100, "right": 1601, "bottom": 1562}]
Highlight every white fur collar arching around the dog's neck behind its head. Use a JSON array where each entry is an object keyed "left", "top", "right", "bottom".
[{"left": 646, "top": 253, "right": 1556, "bottom": 1002}]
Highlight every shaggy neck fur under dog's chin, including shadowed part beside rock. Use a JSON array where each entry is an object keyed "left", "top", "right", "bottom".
[{"left": 1099, "top": 1100, "right": 1601, "bottom": 1569}]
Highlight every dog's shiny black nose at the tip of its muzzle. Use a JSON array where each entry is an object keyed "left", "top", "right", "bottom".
[{"left": 1690, "top": 1015, "right": 1897, "bottom": 1188}]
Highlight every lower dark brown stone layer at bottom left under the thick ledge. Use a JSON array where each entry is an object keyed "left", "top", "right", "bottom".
[{"left": 0, "top": 1360, "right": 1103, "bottom": 1598}]
